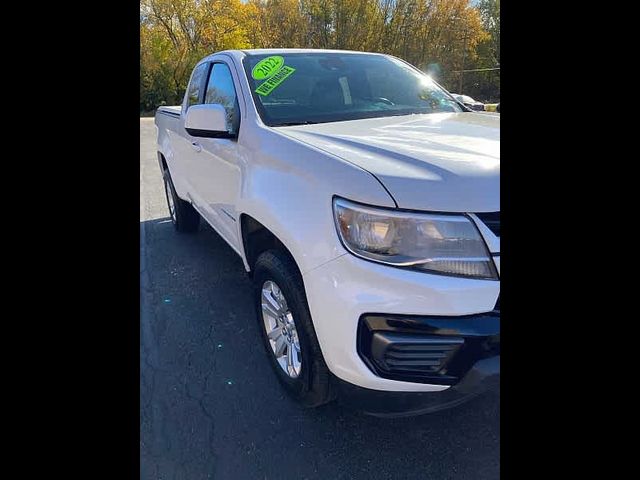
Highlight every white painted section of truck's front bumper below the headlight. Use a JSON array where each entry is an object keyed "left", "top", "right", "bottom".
[{"left": 303, "top": 254, "right": 500, "bottom": 395}]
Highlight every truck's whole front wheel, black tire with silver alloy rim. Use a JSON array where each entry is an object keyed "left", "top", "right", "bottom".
[{"left": 253, "top": 250, "right": 334, "bottom": 407}]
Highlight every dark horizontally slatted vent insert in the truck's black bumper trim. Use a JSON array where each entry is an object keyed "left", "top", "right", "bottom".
[{"left": 371, "top": 332, "right": 464, "bottom": 375}]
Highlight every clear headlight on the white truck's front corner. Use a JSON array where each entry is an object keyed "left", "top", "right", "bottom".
[{"left": 333, "top": 198, "right": 498, "bottom": 280}]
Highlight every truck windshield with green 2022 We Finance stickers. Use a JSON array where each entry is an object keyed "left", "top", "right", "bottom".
[{"left": 243, "top": 52, "right": 462, "bottom": 126}]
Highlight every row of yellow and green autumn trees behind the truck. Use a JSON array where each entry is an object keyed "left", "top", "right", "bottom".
[{"left": 140, "top": 0, "right": 500, "bottom": 112}]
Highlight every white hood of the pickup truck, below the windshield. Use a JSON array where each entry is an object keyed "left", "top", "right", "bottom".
[{"left": 277, "top": 113, "right": 500, "bottom": 212}]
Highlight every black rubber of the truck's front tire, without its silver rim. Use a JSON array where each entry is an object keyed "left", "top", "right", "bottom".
[{"left": 253, "top": 250, "right": 335, "bottom": 407}]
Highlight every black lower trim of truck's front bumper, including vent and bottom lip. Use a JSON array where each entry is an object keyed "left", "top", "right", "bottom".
[{"left": 335, "top": 312, "right": 500, "bottom": 417}]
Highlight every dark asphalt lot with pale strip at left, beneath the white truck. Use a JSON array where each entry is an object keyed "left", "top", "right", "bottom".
[{"left": 140, "top": 119, "right": 500, "bottom": 480}]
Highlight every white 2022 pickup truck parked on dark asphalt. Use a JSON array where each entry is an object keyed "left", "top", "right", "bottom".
[{"left": 155, "top": 49, "right": 500, "bottom": 416}]
